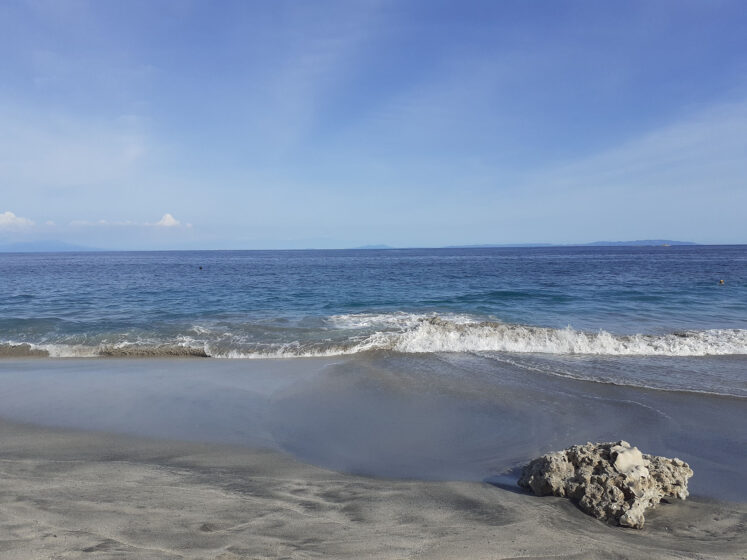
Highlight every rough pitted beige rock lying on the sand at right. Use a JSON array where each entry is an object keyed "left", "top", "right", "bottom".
[{"left": 519, "top": 441, "right": 693, "bottom": 529}]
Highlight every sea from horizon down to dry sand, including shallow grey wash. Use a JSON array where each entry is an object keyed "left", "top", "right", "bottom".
[{"left": 0, "top": 245, "right": 747, "bottom": 501}]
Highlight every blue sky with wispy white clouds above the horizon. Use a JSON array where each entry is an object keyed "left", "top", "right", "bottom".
[{"left": 0, "top": 0, "right": 747, "bottom": 250}]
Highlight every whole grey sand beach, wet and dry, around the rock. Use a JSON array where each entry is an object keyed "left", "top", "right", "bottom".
[{"left": 0, "top": 354, "right": 747, "bottom": 559}]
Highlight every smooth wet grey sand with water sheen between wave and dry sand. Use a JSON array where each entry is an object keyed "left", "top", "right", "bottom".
[{"left": 0, "top": 352, "right": 747, "bottom": 500}]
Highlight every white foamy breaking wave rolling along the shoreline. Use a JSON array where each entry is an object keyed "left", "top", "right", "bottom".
[{"left": 0, "top": 312, "right": 747, "bottom": 358}]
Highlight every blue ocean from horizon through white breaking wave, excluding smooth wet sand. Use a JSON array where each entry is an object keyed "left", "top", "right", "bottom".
[{"left": 0, "top": 246, "right": 747, "bottom": 395}]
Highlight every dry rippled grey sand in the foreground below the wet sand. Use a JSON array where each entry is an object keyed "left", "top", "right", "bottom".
[{"left": 0, "top": 422, "right": 747, "bottom": 560}]
